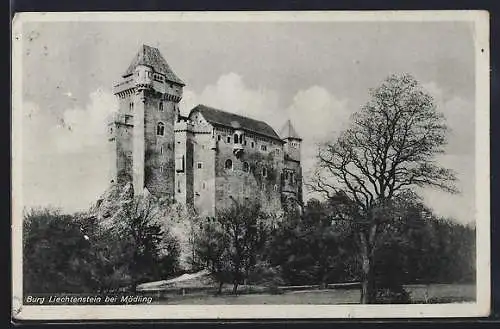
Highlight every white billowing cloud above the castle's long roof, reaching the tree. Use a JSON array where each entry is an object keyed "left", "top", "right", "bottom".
[{"left": 181, "top": 72, "right": 352, "bottom": 188}]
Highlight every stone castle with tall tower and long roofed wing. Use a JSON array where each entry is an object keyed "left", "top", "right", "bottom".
[{"left": 108, "top": 45, "right": 302, "bottom": 216}]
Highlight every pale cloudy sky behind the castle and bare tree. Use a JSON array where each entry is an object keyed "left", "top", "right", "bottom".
[{"left": 21, "top": 17, "right": 475, "bottom": 223}]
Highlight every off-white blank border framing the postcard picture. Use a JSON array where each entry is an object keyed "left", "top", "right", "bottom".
[{"left": 11, "top": 11, "right": 490, "bottom": 320}]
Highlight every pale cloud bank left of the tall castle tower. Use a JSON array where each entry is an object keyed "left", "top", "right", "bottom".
[{"left": 22, "top": 89, "right": 116, "bottom": 211}]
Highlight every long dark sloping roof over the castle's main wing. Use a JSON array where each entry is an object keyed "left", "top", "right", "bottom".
[{"left": 189, "top": 104, "right": 281, "bottom": 140}]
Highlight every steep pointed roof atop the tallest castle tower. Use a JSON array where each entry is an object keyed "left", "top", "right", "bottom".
[{"left": 123, "top": 45, "right": 185, "bottom": 86}]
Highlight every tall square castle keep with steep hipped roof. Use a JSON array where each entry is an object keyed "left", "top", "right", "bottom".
[{"left": 109, "top": 45, "right": 185, "bottom": 200}]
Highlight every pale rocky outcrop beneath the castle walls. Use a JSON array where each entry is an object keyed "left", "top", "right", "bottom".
[{"left": 89, "top": 183, "right": 198, "bottom": 271}]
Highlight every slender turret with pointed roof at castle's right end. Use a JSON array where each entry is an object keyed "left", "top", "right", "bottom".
[{"left": 280, "top": 120, "right": 302, "bottom": 203}]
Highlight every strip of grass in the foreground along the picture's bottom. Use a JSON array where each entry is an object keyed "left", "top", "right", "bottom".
[{"left": 154, "top": 284, "right": 476, "bottom": 305}]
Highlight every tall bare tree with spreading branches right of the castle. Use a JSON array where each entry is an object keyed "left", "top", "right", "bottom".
[{"left": 309, "top": 74, "right": 457, "bottom": 303}]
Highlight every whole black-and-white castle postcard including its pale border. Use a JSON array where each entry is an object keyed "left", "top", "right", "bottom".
[{"left": 12, "top": 11, "right": 490, "bottom": 320}]
